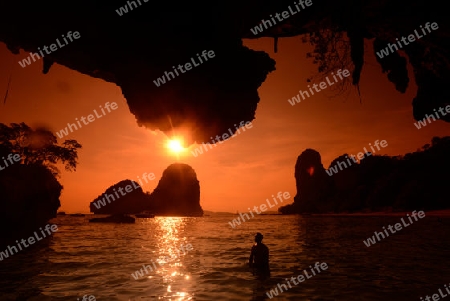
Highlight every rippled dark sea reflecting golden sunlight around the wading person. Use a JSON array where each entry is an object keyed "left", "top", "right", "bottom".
[{"left": 0, "top": 215, "right": 450, "bottom": 301}]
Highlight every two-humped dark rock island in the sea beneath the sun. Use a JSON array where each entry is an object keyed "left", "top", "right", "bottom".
[{"left": 89, "top": 163, "right": 203, "bottom": 216}]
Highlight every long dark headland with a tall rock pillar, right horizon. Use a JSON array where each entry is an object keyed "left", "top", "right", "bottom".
[{"left": 279, "top": 137, "right": 450, "bottom": 214}]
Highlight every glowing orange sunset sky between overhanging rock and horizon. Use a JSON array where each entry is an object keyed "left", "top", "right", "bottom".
[{"left": 0, "top": 37, "right": 450, "bottom": 213}]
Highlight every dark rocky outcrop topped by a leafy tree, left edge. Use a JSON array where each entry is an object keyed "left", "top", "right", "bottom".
[{"left": 0, "top": 123, "right": 81, "bottom": 246}]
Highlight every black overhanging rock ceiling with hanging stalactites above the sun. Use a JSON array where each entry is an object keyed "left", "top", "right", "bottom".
[{"left": 0, "top": 0, "right": 450, "bottom": 143}]
